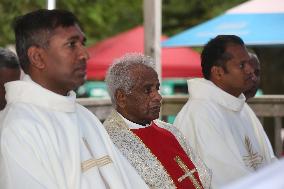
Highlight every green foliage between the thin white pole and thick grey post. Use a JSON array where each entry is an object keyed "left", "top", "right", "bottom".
[{"left": 57, "top": 0, "right": 143, "bottom": 44}]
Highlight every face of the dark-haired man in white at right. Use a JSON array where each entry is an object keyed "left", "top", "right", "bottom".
[{"left": 221, "top": 44, "right": 256, "bottom": 97}]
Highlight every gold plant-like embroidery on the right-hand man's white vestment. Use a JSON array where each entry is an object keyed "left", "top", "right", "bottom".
[{"left": 243, "top": 136, "right": 263, "bottom": 170}]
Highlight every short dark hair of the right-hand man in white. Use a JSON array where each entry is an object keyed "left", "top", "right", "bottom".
[{"left": 201, "top": 35, "right": 244, "bottom": 79}]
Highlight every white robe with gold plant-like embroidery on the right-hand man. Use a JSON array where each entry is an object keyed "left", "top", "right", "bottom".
[{"left": 174, "top": 79, "right": 275, "bottom": 188}]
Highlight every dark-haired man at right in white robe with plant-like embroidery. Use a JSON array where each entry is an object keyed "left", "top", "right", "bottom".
[{"left": 174, "top": 35, "right": 275, "bottom": 188}]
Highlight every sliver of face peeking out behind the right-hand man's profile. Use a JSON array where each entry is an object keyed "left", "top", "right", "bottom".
[{"left": 244, "top": 57, "right": 260, "bottom": 99}]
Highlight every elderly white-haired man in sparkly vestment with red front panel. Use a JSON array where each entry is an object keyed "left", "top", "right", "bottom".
[{"left": 104, "top": 53, "right": 211, "bottom": 189}]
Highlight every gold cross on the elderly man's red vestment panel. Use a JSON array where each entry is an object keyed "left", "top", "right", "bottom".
[{"left": 174, "top": 156, "right": 202, "bottom": 189}]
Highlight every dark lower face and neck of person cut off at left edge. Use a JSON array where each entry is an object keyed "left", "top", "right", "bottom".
[{"left": 0, "top": 68, "right": 21, "bottom": 110}]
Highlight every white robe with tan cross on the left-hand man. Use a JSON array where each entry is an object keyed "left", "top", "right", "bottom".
[{"left": 0, "top": 75, "right": 148, "bottom": 189}]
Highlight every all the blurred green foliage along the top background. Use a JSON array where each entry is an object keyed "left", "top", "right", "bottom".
[{"left": 0, "top": 0, "right": 245, "bottom": 46}]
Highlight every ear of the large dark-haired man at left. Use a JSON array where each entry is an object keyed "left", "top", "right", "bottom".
[{"left": 28, "top": 46, "right": 45, "bottom": 70}]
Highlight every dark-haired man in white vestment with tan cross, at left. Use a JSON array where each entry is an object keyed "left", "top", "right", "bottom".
[{"left": 0, "top": 9, "right": 148, "bottom": 189}]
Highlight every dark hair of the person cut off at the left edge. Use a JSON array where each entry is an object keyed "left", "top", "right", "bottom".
[{"left": 0, "top": 47, "right": 20, "bottom": 69}]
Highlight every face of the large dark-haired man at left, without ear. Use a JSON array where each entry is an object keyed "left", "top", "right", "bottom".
[{"left": 39, "top": 25, "right": 89, "bottom": 95}]
